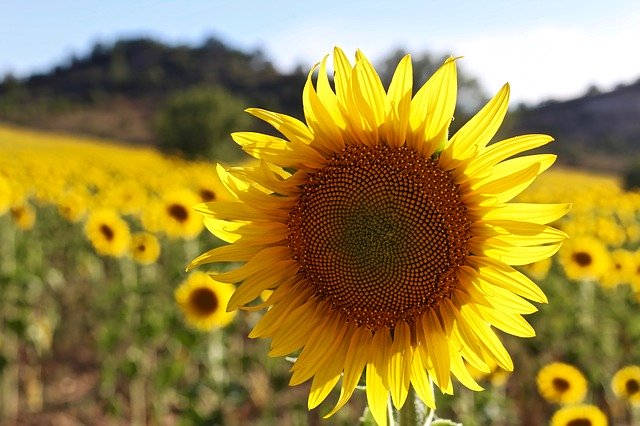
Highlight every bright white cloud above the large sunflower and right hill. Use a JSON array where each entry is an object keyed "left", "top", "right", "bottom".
[{"left": 265, "top": 8, "right": 640, "bottom": 103}]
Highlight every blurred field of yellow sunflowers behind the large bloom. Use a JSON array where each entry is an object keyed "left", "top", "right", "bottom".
[{"left": 0, "top": 122, "right": 640, "bottom": 426}]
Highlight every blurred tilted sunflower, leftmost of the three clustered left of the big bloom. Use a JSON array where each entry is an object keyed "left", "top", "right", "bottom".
[{"left": 84, "top": 209, "right": 131, "bottom": 257}]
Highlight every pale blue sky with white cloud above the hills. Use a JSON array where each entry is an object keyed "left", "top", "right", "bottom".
[{"left": 0, "top": 0, "right": 640, "bottom": 103}]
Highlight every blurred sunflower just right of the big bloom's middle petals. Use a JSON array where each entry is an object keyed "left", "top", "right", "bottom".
[{"left": 558, "top": 235, "right": 611, "bottom": 280}]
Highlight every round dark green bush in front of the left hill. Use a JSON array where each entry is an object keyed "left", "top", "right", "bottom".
[{"left": 155, "top": 87, "right": 249, "bottom": 160}]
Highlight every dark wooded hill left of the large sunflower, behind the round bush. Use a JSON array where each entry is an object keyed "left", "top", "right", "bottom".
[{"left": 0, "top": 38, "right": 306, "bottom": 144}]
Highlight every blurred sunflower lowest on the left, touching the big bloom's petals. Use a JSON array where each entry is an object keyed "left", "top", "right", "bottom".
[{"left": 174, "top": 271, "right": 235, "bottom": 331}]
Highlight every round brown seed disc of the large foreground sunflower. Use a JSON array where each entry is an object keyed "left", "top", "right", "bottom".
[{"left": 289, "top": 143, "right": 471, "bottom": 330}]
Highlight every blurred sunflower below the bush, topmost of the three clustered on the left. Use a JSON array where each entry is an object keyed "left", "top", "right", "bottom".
[{"left": 161, "top": 189, "right": 203, "bottom": 240}]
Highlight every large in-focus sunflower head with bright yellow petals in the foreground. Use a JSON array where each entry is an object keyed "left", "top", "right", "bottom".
[{"left": 190, "top": 48, "right": 569, "bottom": 424}]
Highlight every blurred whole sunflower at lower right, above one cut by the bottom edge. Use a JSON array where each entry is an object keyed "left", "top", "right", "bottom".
[{"left": 536, "top": 362, "right": 587, "bottom": 405}]
